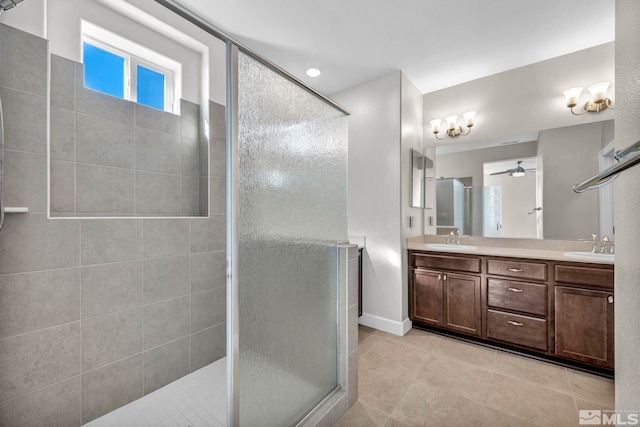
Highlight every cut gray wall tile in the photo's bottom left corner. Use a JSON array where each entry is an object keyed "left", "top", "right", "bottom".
[{"left": 0, "top": 376, "right": 82, "bottom": 427}]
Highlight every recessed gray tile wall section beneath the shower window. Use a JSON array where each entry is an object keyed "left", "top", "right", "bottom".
[{"left": 51, "top": 55, "right": 208, "bottom": 217}]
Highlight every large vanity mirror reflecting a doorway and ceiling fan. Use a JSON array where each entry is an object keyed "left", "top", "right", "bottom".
[{"left": 436, "top": 120, "right": 614, "bottom": 240}]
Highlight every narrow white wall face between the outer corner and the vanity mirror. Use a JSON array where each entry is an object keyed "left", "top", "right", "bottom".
[{"left": 400, "top": 74, "right": 424, "bottom": 320}]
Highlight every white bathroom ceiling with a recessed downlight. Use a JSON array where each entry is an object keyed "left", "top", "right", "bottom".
[{"left": 178, "top": 0, "right": 615, "bottom": 95}]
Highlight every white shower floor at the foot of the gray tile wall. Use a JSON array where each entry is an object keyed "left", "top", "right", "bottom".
[{"left": 85, "top": 358, "right": 227, "bottom": 427}]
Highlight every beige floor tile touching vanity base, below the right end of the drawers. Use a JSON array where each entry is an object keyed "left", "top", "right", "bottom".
[{"left": 493, "top": 351, "right": 572, "bottom": 394}]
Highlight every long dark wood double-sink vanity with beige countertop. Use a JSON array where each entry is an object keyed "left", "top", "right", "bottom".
[{"left": 408, "top": 245, "right": 614, "bottom": 372}]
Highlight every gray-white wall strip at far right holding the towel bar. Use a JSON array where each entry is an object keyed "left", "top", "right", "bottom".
[{"left": 613, "top": 0, "right": 640, "bottom": 411}]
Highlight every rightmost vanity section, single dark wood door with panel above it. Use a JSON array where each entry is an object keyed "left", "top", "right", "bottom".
[{"left": 555, "top": 266, "right": 614, "bottom": 368}]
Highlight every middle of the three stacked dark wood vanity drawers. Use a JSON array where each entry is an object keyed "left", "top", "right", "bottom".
[{"left": 487, "top": 279, "right": 547, "bottom": 316}]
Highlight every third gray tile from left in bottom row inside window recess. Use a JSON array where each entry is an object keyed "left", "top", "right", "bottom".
[{"left": 136, "top": 172, "right": 180, "bottom": 216}]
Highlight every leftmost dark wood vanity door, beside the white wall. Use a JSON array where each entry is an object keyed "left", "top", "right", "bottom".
[{"left": 411, "top": 270, "right": 444, "bottom": 326}]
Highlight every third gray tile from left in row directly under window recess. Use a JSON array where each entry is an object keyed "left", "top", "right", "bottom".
[{"left": 144, "top": 219, "right": 189, "bottom": 258}]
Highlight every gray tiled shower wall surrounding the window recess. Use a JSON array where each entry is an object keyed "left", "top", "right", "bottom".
[{"left": 0, "top": 24, "right": 226, "bottom": 427}]
